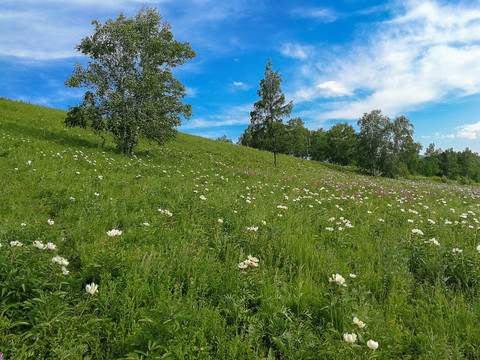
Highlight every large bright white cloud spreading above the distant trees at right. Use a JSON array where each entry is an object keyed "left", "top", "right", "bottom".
[{"left": 288, "top": 0, "right": 480, "bottom": 120}]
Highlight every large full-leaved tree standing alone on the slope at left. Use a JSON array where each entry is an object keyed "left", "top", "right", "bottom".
[{"left": 65, "top": 7, "right": 196, "bottom": 155}]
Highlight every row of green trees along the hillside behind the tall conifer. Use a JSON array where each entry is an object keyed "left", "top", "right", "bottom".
[{"left": 237, "top": 110, "right": 480, "bottom": 184}]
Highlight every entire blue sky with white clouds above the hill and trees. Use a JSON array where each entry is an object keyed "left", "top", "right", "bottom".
[{"left": 0, "top": 0, "right": 480, "bottom": 153}]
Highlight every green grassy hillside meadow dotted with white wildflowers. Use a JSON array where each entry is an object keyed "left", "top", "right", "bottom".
[{"left": 0, "top": 99, "right": 480, "bottom": 359}]
